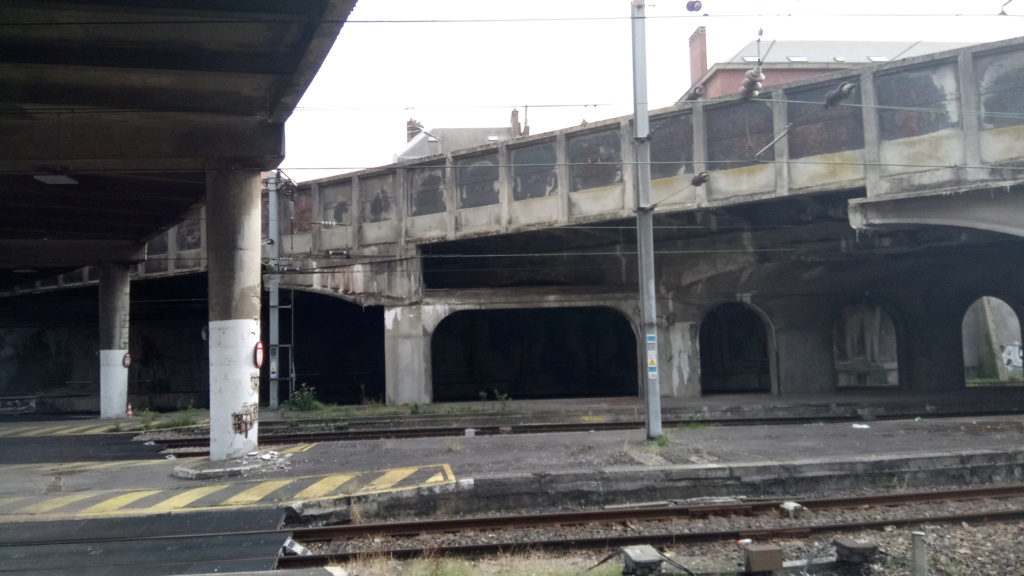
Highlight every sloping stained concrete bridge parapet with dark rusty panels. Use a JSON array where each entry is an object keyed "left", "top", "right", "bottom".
[{"left": 283, "top": 39, "right": 1024, "bottom": 268}]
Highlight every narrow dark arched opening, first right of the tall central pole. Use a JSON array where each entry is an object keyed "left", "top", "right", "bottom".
[{"left": 700, "top": 303, "right": 771, "bottom": 394}]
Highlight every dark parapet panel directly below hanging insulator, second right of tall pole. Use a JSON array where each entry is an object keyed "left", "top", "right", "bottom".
[{"left": 706, "top": 98, "right": 775, "bottom": 170}]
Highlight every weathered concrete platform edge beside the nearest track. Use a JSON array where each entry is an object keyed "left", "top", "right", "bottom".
[{"left": 348, "top": 450, "right": 1024, "bottom": 519}]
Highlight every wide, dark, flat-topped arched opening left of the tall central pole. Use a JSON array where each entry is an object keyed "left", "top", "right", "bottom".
[{"left": 430, "top": 307, "right": 638, "bottom": 402}]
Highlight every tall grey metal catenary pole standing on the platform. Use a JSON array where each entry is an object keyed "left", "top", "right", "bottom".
[{"left": 631, "top": 0, "right": 662, "bottom": 440}]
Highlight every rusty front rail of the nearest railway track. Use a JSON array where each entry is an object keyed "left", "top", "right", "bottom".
[{"left": 278, "top": 509, "right": 1024, "bottom": 569}]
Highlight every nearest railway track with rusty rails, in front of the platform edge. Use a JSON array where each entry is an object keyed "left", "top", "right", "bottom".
[{"left": 8, "top": 485, "right": 1024, "bottom": 568}]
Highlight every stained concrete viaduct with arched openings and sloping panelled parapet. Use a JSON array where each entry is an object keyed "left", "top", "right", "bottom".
[{"left": 2, "top": 33, "right": 1024, "bottom": 448}]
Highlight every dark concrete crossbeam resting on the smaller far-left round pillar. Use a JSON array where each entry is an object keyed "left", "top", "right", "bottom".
[{"left": 0, "top": 240, "right": 145, "bottom": 268}]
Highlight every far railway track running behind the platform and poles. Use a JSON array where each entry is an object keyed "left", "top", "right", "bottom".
[{"left": 149, "top": 412, "right": 1010, "bottom": 456}]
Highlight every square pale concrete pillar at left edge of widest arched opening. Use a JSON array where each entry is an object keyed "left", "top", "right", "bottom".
[{"left": 384, "top": 305, "right": 435, "bottom": 404}]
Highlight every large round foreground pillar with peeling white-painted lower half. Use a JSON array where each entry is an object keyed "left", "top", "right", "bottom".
[{"left": 206, "top": 169, "right": 260, "bottom": 461}]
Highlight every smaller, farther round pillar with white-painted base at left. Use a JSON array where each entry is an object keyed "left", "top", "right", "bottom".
[{"left": 99, "top": 263, "right": 130, "bottom": 418}]
